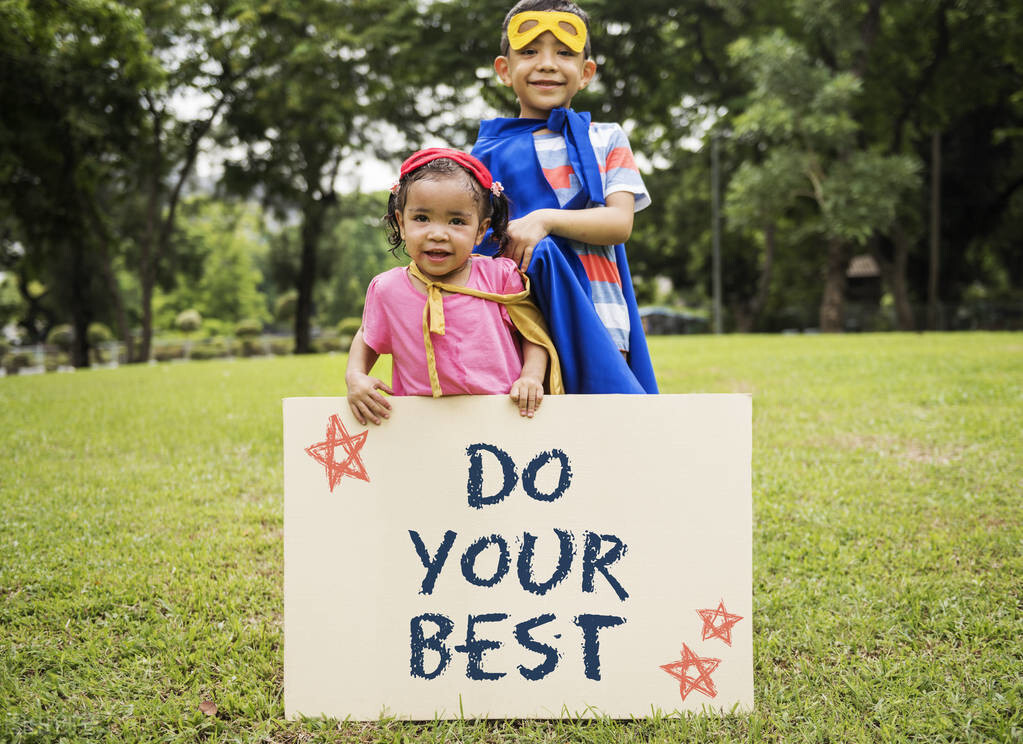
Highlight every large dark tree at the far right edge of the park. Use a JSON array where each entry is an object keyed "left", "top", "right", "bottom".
[{"left": 792, "top": 0, "right": 1023, "bottom": 329}]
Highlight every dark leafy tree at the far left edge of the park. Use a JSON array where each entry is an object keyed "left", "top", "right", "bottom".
[{"left": 0, "top": 0, "right": 155, "bottom": 366}]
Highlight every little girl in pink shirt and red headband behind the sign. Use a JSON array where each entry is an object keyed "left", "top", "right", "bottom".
[{"left": 345, "top": 147, "right": 562, "bottom": 425}]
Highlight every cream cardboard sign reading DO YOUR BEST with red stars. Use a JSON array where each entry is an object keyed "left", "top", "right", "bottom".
[{"left": 284, "top": 395, "right": 753, "bottom": 720}]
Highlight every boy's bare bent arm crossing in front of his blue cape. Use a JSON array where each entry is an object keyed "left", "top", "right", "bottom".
[{"left": 504, "top": 191, "right": 635, "bottom": 271}]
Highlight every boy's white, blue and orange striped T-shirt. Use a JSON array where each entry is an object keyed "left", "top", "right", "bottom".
[{"left": 533, "top": 122, "right": 650, "bottom": 351}]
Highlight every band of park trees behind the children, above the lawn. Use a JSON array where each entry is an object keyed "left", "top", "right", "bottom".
[{"left": 0, "top": 0, "right": 1023, "bottom": 371}]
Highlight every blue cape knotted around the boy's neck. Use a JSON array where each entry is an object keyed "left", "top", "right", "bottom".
[{"left": 473, "top": 108, "right": 658, "bottom": 394}]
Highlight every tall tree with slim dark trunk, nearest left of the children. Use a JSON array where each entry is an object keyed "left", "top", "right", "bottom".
[{"left": 226, "top": 0, "right": 433, "bottom": 354}]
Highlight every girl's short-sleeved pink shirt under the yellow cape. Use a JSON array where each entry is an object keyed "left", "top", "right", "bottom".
[{"left": 362, "top": 256, "right": 523, "bottom": 395}]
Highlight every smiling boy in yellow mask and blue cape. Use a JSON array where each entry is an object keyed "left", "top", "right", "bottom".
[{"left": 473, "top": 0, "right": 657, "bottom": 393}]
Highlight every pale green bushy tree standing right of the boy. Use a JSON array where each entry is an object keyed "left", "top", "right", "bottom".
[{"left": 731, "top": 32, "right": 919, "bottom": 332}]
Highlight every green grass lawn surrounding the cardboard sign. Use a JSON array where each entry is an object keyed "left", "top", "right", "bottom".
[{"left": 0, "top": 334, "right": 1023, "bottom": 743}]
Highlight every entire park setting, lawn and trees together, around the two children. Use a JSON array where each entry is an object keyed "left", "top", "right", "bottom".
[{"left": 0, "top": 0, "right": 1023, "bottom": 744}]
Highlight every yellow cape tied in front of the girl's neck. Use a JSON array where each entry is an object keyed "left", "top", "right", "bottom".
[{"left": 408, "top": 262, "right": 565, "bottom": 398}]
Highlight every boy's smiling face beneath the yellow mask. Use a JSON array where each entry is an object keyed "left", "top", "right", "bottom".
[{"left": 494, "top": 31, "right": 596, "bottom": 119}]
